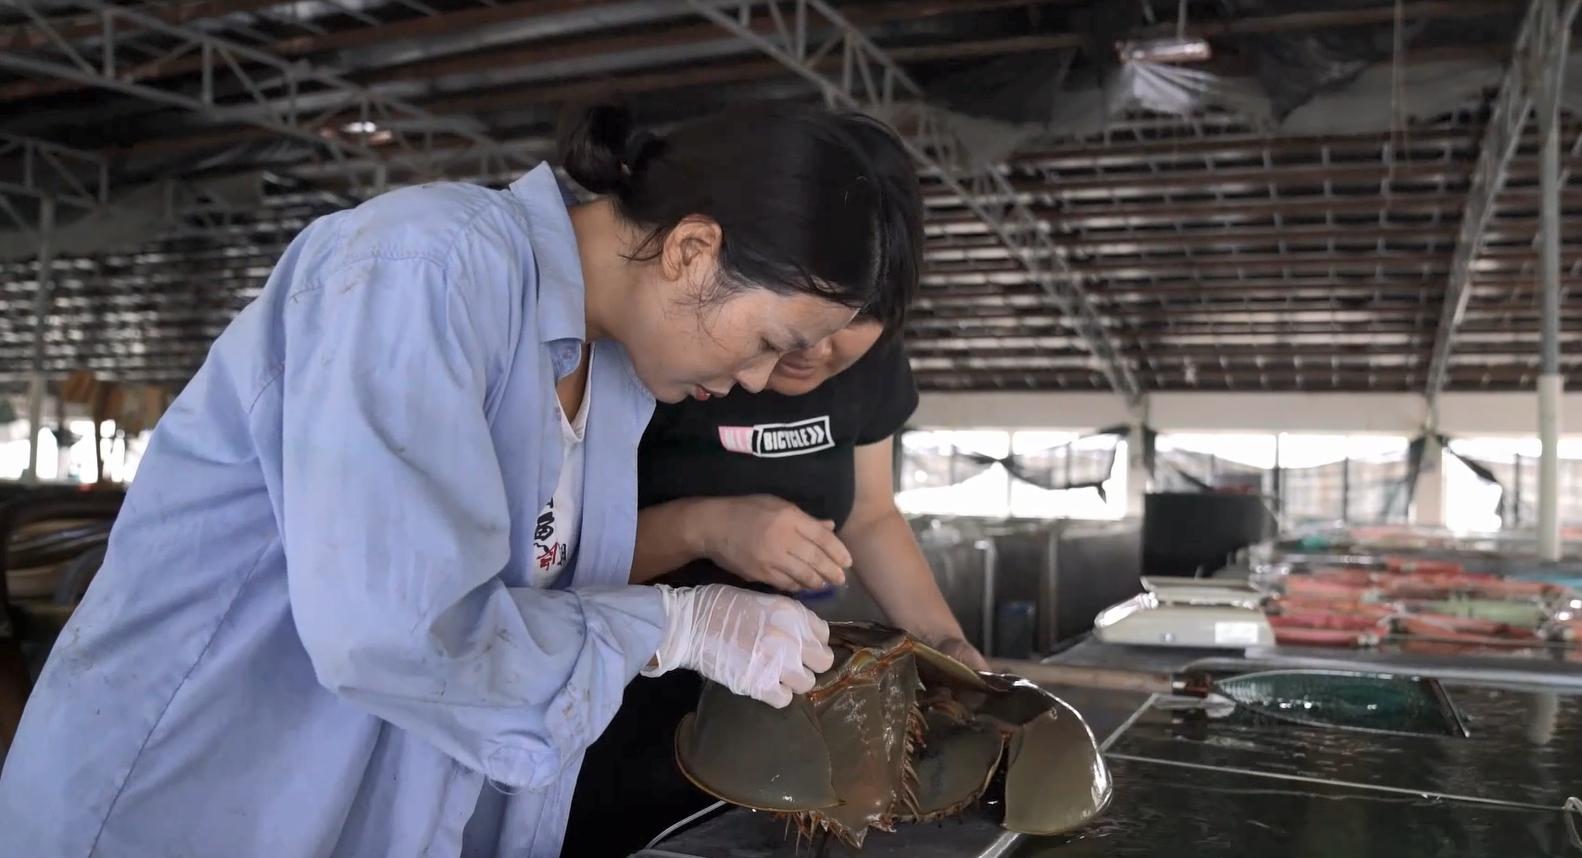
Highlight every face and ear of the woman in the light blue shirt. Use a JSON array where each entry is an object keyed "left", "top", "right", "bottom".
[{"left": 622, "top": 222, "right": 856, "bottom": 402}]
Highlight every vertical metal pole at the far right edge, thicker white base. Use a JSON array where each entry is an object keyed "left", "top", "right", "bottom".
[{"left": 1536, "top": 0, "right": 1569, "bottom": 562}]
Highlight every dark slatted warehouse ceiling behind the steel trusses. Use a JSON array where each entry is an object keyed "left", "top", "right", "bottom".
[{"left": 0, "top": 0, "right": 1582, "bottom": 391}]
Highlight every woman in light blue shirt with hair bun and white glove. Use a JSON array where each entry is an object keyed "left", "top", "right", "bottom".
[{"left": 0, "top": 108, "right": 919, "bottom": 858}]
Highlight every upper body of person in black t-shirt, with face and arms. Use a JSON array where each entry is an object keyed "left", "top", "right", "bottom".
[{"left": 631, "top": 317, "right": 987, "bottom": 668}]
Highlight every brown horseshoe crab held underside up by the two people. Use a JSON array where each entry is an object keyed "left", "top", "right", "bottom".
[{"left": 676, "top": 622, "right": 1112, "bottom": 847}]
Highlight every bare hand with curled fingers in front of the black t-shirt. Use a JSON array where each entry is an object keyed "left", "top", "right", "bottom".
[{"left": 701, "top": 494, "right": 851, "bottom": 592}]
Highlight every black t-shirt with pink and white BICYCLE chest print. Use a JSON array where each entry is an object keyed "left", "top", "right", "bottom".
[{"left": 638, "top": 339, "right": 918, "bottom": 527}]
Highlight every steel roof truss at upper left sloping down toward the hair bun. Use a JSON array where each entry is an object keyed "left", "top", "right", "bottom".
[{"left": 0, "top": 0, "right": 530, "bottom": 189}]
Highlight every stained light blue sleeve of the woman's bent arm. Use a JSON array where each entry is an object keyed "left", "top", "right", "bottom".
[{"left": 282, "top": 248, "right": 664, "bottom": 788}]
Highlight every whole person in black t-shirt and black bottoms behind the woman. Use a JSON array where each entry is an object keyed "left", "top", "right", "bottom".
[{"left": 562, "top": 317, "right": 987, "bottom": 856}]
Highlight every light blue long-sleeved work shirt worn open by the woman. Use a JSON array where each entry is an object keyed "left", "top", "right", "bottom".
[{"left": 0, "top": 166, "right": 664, "bottom": 858}]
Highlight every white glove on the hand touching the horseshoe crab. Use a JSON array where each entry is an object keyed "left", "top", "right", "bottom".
[{"left": 642, "top": 584, "right": 835, "bottom": 709}]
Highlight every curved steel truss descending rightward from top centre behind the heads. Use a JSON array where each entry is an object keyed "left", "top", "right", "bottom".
[{"left": 688, "top": 0, "right": 1142, "bottom": 401}]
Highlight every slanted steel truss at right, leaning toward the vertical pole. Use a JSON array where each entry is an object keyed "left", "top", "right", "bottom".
[{"left": 1425, "top": 0, "right": 1576, "bottom": 401}]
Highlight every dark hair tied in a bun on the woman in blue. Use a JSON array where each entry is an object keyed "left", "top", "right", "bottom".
[{"left": 560, "top": 104, "right": 922, "bottom": 336}]
